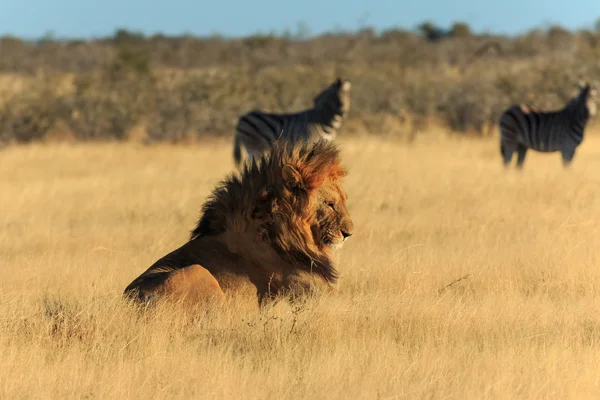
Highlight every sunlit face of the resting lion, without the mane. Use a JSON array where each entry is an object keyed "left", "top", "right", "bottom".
[{"left": 311, "top": 180, "right": 354, "bottom": 250}]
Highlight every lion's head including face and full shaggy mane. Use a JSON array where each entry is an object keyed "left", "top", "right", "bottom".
[{"left": 191, "top": 141, "right": 354, "bottom": 283}]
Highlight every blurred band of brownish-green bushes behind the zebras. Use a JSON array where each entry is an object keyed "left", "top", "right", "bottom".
[{"left": 0, "top": 23, "right": 600, "bottom": 142}]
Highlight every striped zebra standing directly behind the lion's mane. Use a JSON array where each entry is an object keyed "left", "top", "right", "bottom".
[{"left": 233, "top": 79, "right": 350, "bottom": 168}]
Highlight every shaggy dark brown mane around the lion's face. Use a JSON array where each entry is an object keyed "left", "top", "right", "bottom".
[{"left": 190, "top": 141, "right": 345, "bottom": 282}]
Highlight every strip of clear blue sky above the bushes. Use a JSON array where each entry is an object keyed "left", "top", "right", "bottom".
[{"left": 0, "top": 0, "right": 600, "bottom": 38}]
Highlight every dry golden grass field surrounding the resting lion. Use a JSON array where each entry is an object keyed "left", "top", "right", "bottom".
[{"left": 0, "top": 134, "right": 600, "bottom": 399}]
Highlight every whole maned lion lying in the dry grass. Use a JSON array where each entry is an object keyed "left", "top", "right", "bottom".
[{"left": 124, "top": 141, "right": 354, "bottom": 306}]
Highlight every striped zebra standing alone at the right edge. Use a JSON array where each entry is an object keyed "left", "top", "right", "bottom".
[{"left": 500, "top": 84, "right": 596, "bottom": 169}]
